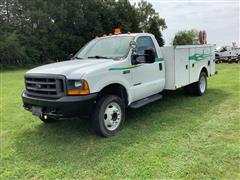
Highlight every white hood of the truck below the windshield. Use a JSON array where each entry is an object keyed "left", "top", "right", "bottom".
[{"left": 26, "top": 59, "right": 114, "bottom": 78}]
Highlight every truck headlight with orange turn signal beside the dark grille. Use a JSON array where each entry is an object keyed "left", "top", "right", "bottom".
[{"left": 67, "top": 79, "right": 90, "bottom": 95}]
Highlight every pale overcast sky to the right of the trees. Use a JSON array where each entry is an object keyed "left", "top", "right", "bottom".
[{"left": 130, "top": 0, "right": 240, "bottom": 46}]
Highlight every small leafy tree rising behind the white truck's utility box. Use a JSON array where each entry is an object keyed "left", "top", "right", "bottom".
[{"left": 173, "top": 30, "right": 198, "bottom": 46}]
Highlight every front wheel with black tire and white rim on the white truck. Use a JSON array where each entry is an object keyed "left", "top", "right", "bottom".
[{"left": 92, "top": 95, "right": 125, "bottom": 137}]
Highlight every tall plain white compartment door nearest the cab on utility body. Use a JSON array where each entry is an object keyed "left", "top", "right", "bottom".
[{"left": 175, "top": 47, "right": 189, "bottom": 88}]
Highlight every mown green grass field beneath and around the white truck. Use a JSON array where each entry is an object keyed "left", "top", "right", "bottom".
[{"left": 0, "top": 64, "right": 240, "bottom": 179}]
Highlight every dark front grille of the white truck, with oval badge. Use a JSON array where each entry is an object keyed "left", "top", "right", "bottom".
[{"left": 25, "top": 75, "right": 65, "bottom": 98}]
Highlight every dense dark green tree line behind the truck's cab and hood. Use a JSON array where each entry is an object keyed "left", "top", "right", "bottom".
[{"left": 0, "top": 0, "right": 167, "bottom": 65}]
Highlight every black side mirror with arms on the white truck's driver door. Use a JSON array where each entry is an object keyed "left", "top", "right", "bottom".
[{"left": 132, "top": 49, "right": 156, "bottom": 64}]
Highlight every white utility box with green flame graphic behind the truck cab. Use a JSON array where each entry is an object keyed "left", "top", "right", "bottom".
[{"left": 161, "top": 45, "right": 215, "bottom": 90}]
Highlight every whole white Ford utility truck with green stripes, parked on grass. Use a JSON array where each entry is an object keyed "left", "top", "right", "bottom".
[{"left": 22, "top": 33, "right": 215, "bottom": 137}]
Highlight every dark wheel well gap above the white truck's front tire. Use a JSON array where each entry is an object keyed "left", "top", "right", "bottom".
[{"left": 99, "top": 83, "right": 128, "bottom": 106}]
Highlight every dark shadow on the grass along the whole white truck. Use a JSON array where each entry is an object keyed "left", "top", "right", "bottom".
[{"left": 14, "top": 89, "right": 229, "bottom": 167}]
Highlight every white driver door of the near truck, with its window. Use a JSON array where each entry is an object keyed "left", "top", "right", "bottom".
[{"left": 132, "top": 36, "right": 163, "bottom": 101}]
